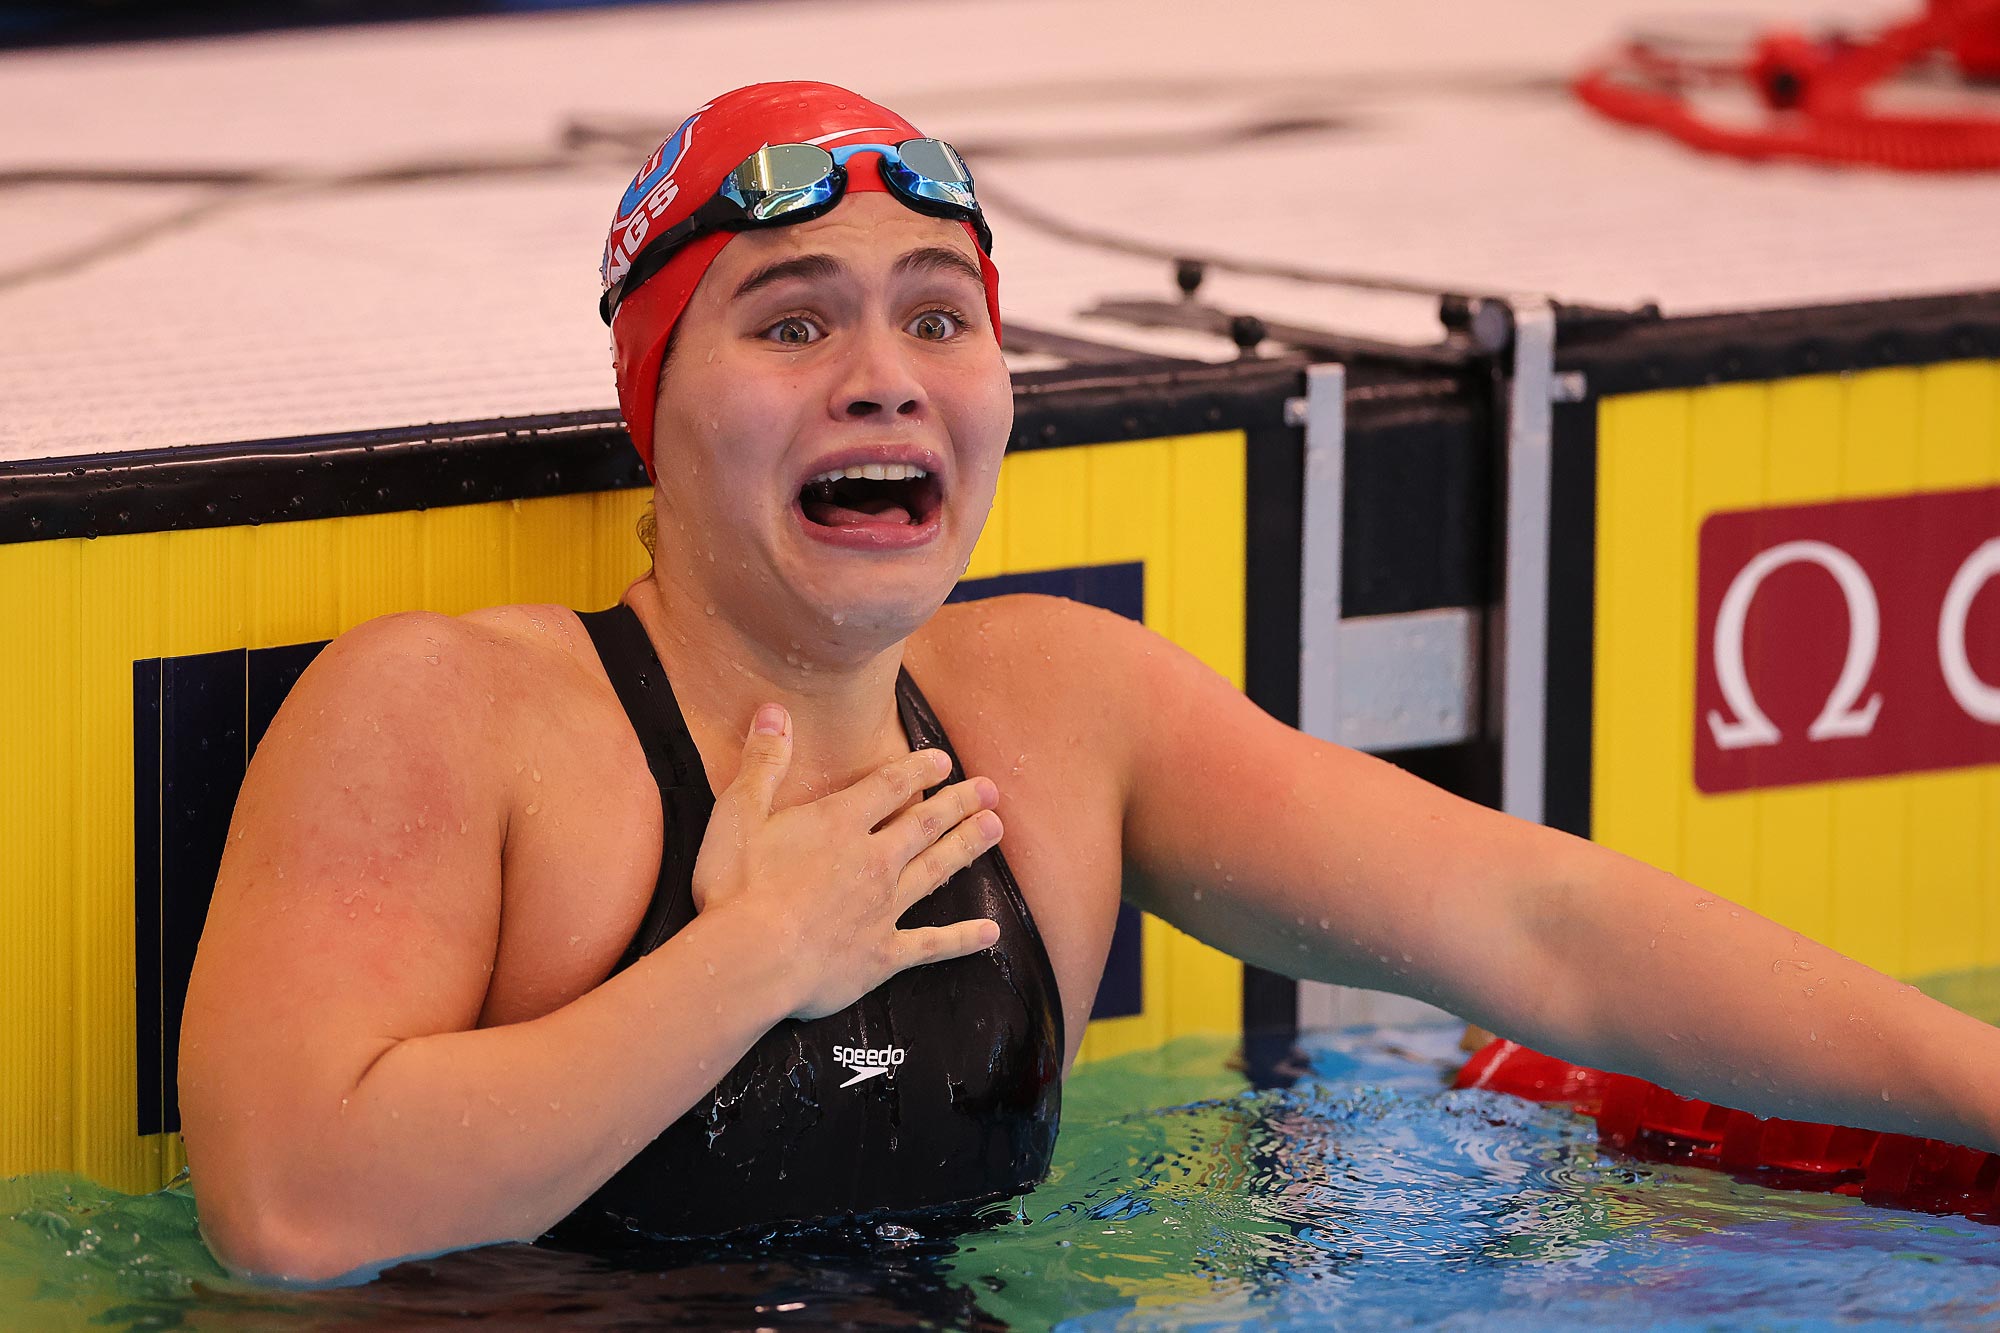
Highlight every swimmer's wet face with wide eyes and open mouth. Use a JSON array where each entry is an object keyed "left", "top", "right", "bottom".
[{"left": 654, "top": 192, "right": 1014, "bottom": 642}]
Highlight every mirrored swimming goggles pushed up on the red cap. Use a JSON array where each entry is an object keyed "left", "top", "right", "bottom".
[{"left": 598, "top": 138, "right": 994, "bottom": 324}]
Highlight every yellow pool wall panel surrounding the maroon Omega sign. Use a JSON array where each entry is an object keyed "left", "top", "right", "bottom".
[{"left": 1590, "top": 360, "right": 2000, "bottom": 979}]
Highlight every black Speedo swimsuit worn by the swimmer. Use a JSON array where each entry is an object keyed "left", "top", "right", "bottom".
[{"left": 556, "top": 604, "right": 1064, "bottom": 1241}]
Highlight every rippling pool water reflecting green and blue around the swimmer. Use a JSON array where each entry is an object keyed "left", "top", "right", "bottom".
[{"left": 0, "top": 1027, "right": 2000, "bottom": 1333}]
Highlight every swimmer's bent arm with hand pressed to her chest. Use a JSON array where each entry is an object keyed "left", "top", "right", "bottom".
[{"left": 180, "top": 616, "right": 1000, "bottom": 1281}]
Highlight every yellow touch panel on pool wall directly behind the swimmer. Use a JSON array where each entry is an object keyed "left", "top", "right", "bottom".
[{"left": 0, "top": 432, "right": 1244, "bottom": 1189}]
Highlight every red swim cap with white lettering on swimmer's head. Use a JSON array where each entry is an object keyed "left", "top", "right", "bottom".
[{"left": 600, "top": 82, "right": 1000, "bottom": 478}]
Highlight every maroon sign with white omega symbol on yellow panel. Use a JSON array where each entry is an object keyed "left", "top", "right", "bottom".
[{"left": 1694, "top": 486, "right": 2000, "bottom": 793}]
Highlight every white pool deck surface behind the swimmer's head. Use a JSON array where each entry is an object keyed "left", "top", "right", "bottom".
[{"left": 0, "top": 0, "right": 2000, "bottom": 458}]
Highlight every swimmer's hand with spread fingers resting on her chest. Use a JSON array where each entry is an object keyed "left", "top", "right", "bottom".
[{"left": 694, "top": 705, "right": 1000, "bottom": 1019}]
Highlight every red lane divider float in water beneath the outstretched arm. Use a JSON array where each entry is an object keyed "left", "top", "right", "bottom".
[{"left": 1454, "top": 1041, "right": 2000, "bottom": 1223}]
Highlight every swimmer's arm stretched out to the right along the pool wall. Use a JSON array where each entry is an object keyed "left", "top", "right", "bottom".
[{"left": 1044, "top": 606, "right": 2000, "bottom": 1151}]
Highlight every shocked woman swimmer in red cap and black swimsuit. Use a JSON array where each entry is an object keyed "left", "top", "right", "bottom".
[{"left": 180, "top": 84, "right": 2000, "bottom": 1279}]
